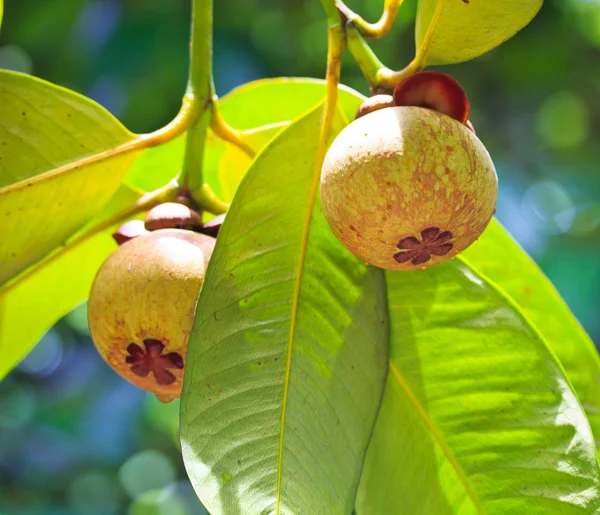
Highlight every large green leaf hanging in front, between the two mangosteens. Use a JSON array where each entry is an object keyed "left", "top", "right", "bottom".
[{"left": 181, "top": 103, "right": 388, "bottom": 515}]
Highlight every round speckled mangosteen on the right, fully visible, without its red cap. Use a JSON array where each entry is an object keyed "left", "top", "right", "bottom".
[{"left": 321, "top": 107, "right": 498, "bottom": 270}]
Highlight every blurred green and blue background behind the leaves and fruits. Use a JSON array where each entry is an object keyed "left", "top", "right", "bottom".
[{"left": 0, "top": 0, "right": 600, "bottom": 515}]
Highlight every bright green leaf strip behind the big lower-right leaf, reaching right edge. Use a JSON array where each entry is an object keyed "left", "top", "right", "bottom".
[{"left": 459, "top": 220, "right": 600, "bottom": 450}]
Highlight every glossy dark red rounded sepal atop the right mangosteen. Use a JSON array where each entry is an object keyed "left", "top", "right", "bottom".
[{"left": 394, "top": 72, "right": 471, "bottom": 124}]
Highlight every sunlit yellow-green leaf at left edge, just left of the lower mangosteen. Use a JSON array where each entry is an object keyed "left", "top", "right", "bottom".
[{"left": 0, "top": 186, "right": 140, "bottom": 379}]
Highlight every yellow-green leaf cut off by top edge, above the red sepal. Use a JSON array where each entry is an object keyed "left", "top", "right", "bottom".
[{"left": 415, "top": 0, "right": 543, "bottom": 65}]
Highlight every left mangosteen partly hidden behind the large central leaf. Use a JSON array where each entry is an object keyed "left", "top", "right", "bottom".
[{"left": 88, "top": 229, "right": 216, "bottom": 402}]
